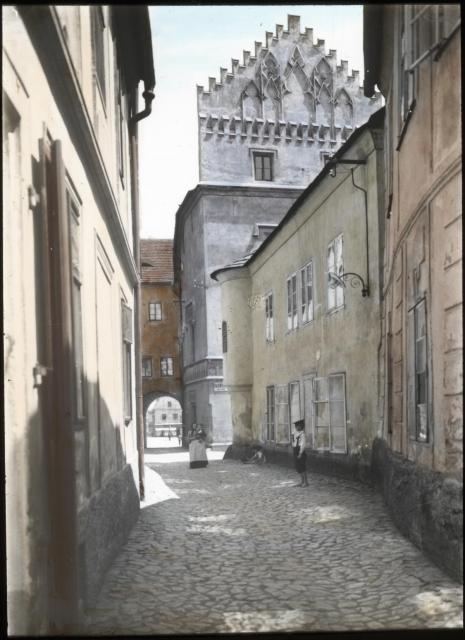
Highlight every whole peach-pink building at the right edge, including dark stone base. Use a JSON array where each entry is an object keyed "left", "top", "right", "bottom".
[{"left": 364, "top": 4, "right": 463, "bottom": 579}]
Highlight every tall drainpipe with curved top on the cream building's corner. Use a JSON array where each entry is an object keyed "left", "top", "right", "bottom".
[{"left": 129, "top": 89, "right": 155, "bottom": 500}]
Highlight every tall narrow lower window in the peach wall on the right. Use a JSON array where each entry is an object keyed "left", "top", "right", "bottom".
[{"left": 408, "top": 299, "right": 429, "bottom": 442}]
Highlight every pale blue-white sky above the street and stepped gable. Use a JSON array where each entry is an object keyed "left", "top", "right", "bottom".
[{"left": 139, "top": 4, "right": 363, "bottom": 238}]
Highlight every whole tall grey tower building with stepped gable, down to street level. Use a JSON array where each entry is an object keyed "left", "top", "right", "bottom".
[{"left": 174, "top": 16, "right": 381, "bottom": 444}]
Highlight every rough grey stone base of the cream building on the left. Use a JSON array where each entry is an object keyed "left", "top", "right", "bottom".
[{"left": 78, "top": 465, "right": 140, "bottom": 608}]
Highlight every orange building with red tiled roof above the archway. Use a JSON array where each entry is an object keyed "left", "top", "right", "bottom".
[{"left": 140, "top": 240, "right": 182, "bottom": 437}]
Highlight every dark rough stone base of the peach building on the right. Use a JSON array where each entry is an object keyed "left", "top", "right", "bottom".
[{"left": 372, "top": 438, "right": 463, "bottom": 582}]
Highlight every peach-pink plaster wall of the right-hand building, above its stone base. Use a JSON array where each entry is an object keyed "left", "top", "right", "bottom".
[{"left": 381, "top": 8, "right": 463, "bottom": 473}]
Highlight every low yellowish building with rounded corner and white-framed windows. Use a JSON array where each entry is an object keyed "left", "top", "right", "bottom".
[{"left": 212, "top": 109, "right": 384, "bottom": 476}]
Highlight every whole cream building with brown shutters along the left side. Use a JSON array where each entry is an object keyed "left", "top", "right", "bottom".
[{"left": 2, "top": 5, "right": 155, "bottom": 636}]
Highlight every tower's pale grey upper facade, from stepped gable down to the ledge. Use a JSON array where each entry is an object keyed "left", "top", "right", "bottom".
[{"left": 197, "top": 16, "right": 381, "bottom": 186}]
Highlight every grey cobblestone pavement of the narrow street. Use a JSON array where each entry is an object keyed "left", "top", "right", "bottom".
[{"left": 87, "top": 452, "right": 462, "bottom": 635}]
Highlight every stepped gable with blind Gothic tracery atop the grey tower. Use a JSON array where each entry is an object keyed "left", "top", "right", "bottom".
[{"left": 197, "top": 15, "right": 381, "bottom": 146}]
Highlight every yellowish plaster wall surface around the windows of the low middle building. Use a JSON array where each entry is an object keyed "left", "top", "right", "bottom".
[{"left": 222, "top": 126, "right": 381, "bottom": 453}]
